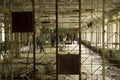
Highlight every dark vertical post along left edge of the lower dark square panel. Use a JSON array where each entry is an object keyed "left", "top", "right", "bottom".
[{"left": 55, "top": 0, "right": 58, "bottom": 80}]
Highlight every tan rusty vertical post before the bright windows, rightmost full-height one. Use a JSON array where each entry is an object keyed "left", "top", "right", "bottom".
[{"left": 102, "top": 0, "right": 105, "bottom": 80}]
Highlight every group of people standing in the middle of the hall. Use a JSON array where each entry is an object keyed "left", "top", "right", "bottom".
[{"left": 28, "top": 33, "right": 75, "bottom": 52}]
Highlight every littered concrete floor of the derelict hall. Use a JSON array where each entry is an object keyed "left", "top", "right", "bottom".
[{"left": 0, "top": 43, "right": 120, "bottom": 80}]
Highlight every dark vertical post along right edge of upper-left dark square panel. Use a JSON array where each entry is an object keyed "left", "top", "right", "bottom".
[{"left": 32, "top": 0, "right": 36, "bottom": 80}]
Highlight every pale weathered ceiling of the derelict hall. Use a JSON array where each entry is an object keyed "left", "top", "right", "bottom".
[{"left": 0, "top": 0, "right": 120, "bottom": 29}]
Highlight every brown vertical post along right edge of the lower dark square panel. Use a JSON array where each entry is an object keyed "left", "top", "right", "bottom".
[{"left": 79, "top": 0, "right": 82, "bottom": 80}]
